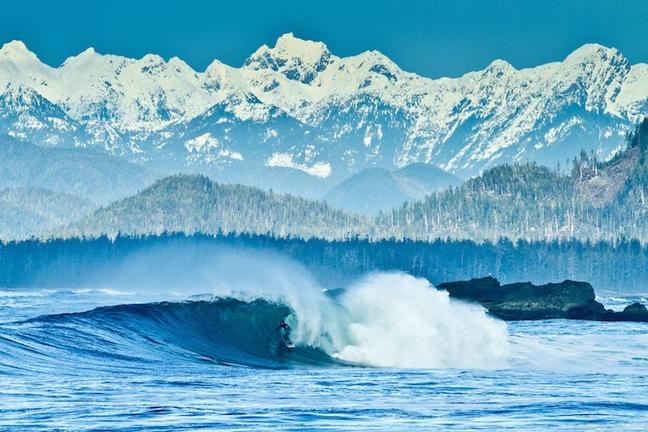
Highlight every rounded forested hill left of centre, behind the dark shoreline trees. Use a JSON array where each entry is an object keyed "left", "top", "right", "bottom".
[{"left": 57, "top": 175, "right": 372, "bottom": 239}]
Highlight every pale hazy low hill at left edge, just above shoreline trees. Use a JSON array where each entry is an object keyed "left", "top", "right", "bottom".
[{"left": 0, "top": 188, "right": 95, "bottom": 241}]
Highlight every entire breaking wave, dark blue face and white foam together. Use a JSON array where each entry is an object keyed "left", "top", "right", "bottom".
[{"left": 0, "top": 274, "right": 508, "bottom": 369}]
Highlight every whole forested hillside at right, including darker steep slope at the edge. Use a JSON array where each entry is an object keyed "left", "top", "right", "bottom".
[{"left": 376, "top": 120, "right": 648, "bottom": 242}]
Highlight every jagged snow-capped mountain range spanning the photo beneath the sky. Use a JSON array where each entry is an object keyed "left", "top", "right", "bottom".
[{"left": 0, "top": 34, "right": 648, "bottom": 179}]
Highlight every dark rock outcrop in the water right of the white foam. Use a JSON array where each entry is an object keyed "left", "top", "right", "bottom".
[{"left": 438, "top": 277, "right": 648, "bottom": 322}]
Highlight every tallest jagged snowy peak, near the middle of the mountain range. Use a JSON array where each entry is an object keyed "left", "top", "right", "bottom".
[{"left": 244, "top": 33, "right": 333, "bottom": 84}]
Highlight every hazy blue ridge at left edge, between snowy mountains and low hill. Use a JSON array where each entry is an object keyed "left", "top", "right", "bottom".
[{"left": 0, "top": 136, "right": 153, "bottom": 203}]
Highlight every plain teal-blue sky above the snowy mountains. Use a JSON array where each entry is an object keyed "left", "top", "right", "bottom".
[{"left": 0, "top": 0, "right": 648, "bottom": 77}]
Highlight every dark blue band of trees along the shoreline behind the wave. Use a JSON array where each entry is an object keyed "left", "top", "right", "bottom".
[{"left": 0, "top": 234, "right": 648, "bottom": 293}]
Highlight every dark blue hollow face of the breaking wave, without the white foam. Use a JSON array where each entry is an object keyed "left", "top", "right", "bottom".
[{"left": 5, "top": 298, "right": 336, "bottom": 367}]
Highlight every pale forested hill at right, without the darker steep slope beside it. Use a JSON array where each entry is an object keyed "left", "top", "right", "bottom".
[{"left": 378, "top": 164, "right": 580, "bottom": 240}]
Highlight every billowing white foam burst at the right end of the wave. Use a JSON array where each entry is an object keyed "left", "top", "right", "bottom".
[{"left": 335, "top": 273, "right": 508, "bottom": 368}]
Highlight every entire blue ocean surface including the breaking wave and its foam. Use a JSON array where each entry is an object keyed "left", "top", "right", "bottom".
[{"left": 0, "top": 274, "right": 648, "bottom": 431}]
